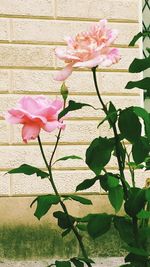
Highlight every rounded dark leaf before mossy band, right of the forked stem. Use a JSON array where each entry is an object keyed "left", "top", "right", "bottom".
[{"left": 87, "top": 213, "right": 112, "bottom": 238}]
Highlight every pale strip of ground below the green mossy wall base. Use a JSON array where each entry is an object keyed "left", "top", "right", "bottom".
[{"left": 0, "top": 257, "right": 124, "bottom": 267}]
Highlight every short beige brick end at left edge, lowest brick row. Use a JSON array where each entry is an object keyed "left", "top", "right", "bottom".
[{"left": 0, "top": 172, "right": 10, "bottom": 196}]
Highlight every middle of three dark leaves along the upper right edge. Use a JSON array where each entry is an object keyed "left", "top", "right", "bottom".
[{"left": 129, "top": 56, "right": 150, "bottom": 73}]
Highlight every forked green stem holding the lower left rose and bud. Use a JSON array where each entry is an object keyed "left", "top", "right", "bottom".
[{"left": 38, "top": 136, "right": 92, "bottom": 267}]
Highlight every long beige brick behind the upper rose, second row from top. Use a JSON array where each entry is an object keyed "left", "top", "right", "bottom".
[{"left": 13, "top": 19, "right": 139, "bottom": 45}]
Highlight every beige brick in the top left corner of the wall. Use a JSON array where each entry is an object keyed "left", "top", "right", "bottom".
[{"left": 0, "top": 0, "right": 54, "bottom": 17}]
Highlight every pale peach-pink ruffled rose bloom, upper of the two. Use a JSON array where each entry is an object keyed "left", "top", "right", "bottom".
[{"left": 54, "top": 19, "right": 120, "bottom": 81}]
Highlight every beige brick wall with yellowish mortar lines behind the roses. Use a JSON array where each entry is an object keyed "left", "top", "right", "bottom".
[{"left": 0, "top": 0, "right": 144, "bottom": 203}]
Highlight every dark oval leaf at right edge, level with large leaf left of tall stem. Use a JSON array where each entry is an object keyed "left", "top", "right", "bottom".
[{"left": 132, "top": 137, "right": 150, "bottom": 164}]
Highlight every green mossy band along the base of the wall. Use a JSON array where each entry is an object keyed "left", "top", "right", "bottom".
[{"left": 0, "top": 224, "right": 125, "bottom": 260}]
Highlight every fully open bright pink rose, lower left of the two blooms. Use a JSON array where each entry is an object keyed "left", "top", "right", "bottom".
[{"left": 6, "top": 96, "right": 65, "bottom": 143}]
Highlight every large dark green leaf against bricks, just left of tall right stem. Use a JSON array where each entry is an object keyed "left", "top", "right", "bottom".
[{"left": 86, "top": 137, "right": 114, "bottom": 175}]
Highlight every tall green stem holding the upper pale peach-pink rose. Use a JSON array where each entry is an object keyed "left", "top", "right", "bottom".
[{"left": 92, "top": 67, "right": 128, "bottom": 199}]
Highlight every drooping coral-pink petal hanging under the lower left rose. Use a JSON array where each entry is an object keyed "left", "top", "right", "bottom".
[{"left": 22, "top": 123, "right": 40, "bottom": 143}]
